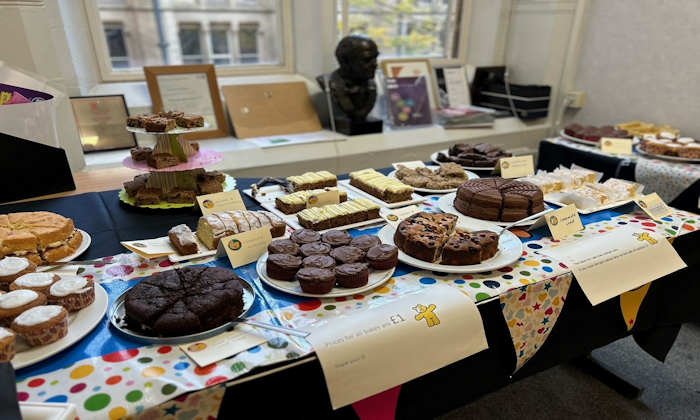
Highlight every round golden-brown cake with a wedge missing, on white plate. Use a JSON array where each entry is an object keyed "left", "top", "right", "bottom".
[{"left": 394, "top": 212, "right": 498, "bottom": 265}]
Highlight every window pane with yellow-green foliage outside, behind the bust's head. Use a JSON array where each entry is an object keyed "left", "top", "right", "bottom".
[{"left": 337, "top": 0, "right": 465, "bottom": 59}]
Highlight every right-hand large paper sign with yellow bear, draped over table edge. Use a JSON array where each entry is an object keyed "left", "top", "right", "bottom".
[{"left": 538, "top": 226, "right": 686, "bottom": 305}]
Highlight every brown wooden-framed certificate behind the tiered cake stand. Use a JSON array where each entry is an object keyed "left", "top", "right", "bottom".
[{"left": 143, "top": 64, "right": 229, "bottom": 140}]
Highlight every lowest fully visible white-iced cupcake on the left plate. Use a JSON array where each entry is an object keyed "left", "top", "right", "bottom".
[{"left": 12, "top": 305, "right": 68, "bottom": 346}]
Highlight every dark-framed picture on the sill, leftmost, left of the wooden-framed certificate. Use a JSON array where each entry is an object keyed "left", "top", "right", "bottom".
[{"left": 70, "top": 95, "right": 136, "bottom": 153}]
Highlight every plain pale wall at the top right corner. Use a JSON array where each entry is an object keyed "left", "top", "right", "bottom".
[{"left": 567, "top": 0, "right": 700, "bottom": 137}]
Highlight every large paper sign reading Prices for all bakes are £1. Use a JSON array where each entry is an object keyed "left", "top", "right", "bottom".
[{"left": 307, "top": 284, "right": 488, "bottom": 409}]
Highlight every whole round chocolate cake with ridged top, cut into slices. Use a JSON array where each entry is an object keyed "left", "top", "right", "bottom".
[{"left": 454, "top": 177, "right": 544, "bottom": 222}]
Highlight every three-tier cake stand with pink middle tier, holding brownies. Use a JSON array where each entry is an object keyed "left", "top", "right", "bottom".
[{"left": 119, "top": 124, "right": 236, "bottom": 210}]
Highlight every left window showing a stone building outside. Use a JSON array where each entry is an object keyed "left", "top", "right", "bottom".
[{"left": 88, "top": 0, "right": 293, "bottom": 80}]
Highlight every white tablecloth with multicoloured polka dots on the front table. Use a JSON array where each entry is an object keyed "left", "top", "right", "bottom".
[{"left": 17, "top": 205, "right": 697, "bottom": 419}]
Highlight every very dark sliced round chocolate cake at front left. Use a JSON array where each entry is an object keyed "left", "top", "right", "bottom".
[{"left": 124, "top": 267, "right": 243, "bottom": 337}]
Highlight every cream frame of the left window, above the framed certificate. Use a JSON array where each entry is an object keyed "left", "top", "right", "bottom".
[{"left": 83, "top": 0, "right": 295, "bottom": 82}]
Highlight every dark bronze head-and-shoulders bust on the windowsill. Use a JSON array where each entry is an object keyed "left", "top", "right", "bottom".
[{"left": 316, "top": 35, "right": 381, "bottom": 134}]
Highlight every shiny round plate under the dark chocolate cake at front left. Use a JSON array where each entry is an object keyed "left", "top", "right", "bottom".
[{"left": 109, "top": 279, "right": 255, "bottom": 344}]
